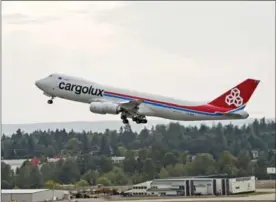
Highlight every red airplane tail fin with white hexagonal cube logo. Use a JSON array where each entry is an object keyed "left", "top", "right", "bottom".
[{"left": 208, "top": 79, "right": 260, "bottom": 110}]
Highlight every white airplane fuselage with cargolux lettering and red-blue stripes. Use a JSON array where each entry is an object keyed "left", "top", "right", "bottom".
[{"left": 36, "top": 74, "right": 248, "bottom": 121}]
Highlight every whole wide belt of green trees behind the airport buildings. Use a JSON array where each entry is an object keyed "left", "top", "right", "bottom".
[{"left": 1, "top": 118, "right": 275, "bottom": 188}]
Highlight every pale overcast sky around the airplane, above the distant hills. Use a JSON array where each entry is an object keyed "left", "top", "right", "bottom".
[{"left": 2, "top": 1, "right": 275, "bottom": 123}]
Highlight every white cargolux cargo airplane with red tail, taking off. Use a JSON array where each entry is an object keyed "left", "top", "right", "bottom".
[{"left": 35, "top": 73, "right": 260, "bottom": 124}]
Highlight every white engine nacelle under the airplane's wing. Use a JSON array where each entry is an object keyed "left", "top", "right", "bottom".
[{"left": 90, "top": 102, "right": 120, "bottom": 114}]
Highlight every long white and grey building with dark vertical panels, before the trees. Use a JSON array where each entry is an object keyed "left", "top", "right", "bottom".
[{"left": 127, "top": 176, "right": 256, "bottom": 196}]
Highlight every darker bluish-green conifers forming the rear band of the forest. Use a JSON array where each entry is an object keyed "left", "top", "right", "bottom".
[{"left": 1, "top": 119, "right": 275, "bottom": 159}]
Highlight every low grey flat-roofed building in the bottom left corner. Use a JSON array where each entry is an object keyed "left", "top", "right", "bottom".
[{"left": 1, "top": 189, "right": 69, "bottom": 202}]
